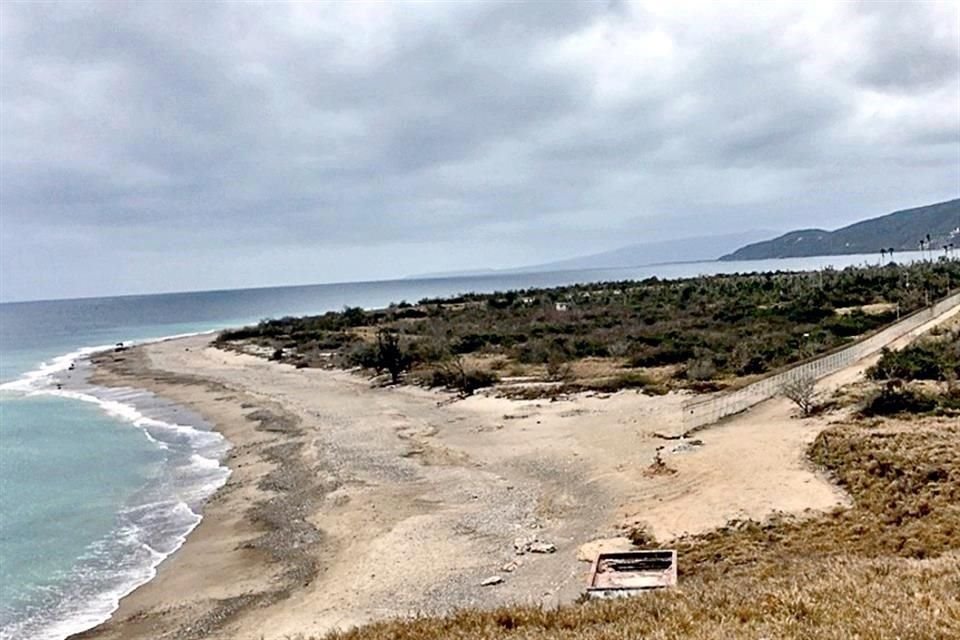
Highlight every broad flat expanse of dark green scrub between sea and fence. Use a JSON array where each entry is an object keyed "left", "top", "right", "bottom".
[{"left": 219, "top": 261, "right": 960, "bottom": 392}]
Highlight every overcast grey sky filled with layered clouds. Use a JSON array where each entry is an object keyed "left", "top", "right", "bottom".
[{"left": 0, "top": 0, "right": 960, "bottom": 300}]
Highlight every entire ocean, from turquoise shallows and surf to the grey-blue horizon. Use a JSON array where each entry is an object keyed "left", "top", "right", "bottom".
[{"left": 0, "top": 253, "right": 921, "bottom": 640}]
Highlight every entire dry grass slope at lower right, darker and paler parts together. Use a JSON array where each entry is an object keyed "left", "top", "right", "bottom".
[{"left": 310, "top": 420, "right": 960, "bottom": 640}]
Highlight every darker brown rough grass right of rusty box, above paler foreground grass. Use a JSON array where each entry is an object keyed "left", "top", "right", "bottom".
[{"left": 678, "top": 420, "right": 960, "bottom": 575}]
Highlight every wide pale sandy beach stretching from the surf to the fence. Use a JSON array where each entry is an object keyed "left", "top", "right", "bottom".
[{"left": 71, "top": 302, "right": 956, "bottom": 640}]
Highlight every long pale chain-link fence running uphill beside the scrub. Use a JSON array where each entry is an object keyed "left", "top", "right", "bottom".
[{"left": 683, "top": 293, "right": 960, "bottom": 432}]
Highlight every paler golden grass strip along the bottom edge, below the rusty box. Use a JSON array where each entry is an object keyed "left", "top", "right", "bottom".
[{"left": 312, "top": 557, "right": 960, "bottom": 640}]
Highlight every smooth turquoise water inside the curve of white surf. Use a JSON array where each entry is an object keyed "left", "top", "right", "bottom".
[{"left": 0, "top": 396, "right": 163, "bottom": 637}]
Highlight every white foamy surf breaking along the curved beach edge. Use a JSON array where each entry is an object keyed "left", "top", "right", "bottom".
[{"left": 0, "top": 332, "right": 230, "bottom": 640}]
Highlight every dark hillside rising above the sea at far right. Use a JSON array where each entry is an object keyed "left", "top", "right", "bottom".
[{"left": 720, "top": 199, "right": 960, "bottom": 260}]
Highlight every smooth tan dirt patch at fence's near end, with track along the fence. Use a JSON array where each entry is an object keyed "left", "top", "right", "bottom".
[{"left": 620, "top": 298, "right": 960, "bottom": 540}]
